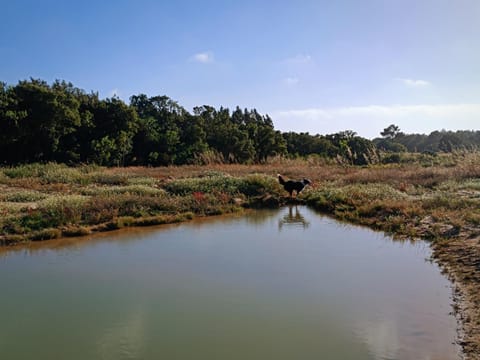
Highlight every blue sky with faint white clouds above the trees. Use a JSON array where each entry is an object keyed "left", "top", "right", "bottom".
[{"left": 0, "top": 0, "right": 480, "bottom": 138}]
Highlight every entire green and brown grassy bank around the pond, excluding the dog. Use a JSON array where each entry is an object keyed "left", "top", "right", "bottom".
[{"left": 0, "top": 152, "right": 480, "bottom": 359}]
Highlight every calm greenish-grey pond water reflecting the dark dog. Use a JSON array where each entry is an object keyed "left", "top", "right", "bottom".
[{"left": 0, "top": 207, "right": 459, "bottom": 360}]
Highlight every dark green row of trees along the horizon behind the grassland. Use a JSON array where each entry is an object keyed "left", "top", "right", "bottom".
[{"left": 0, "top": 79, "right": 480, "bottom": 166}]
